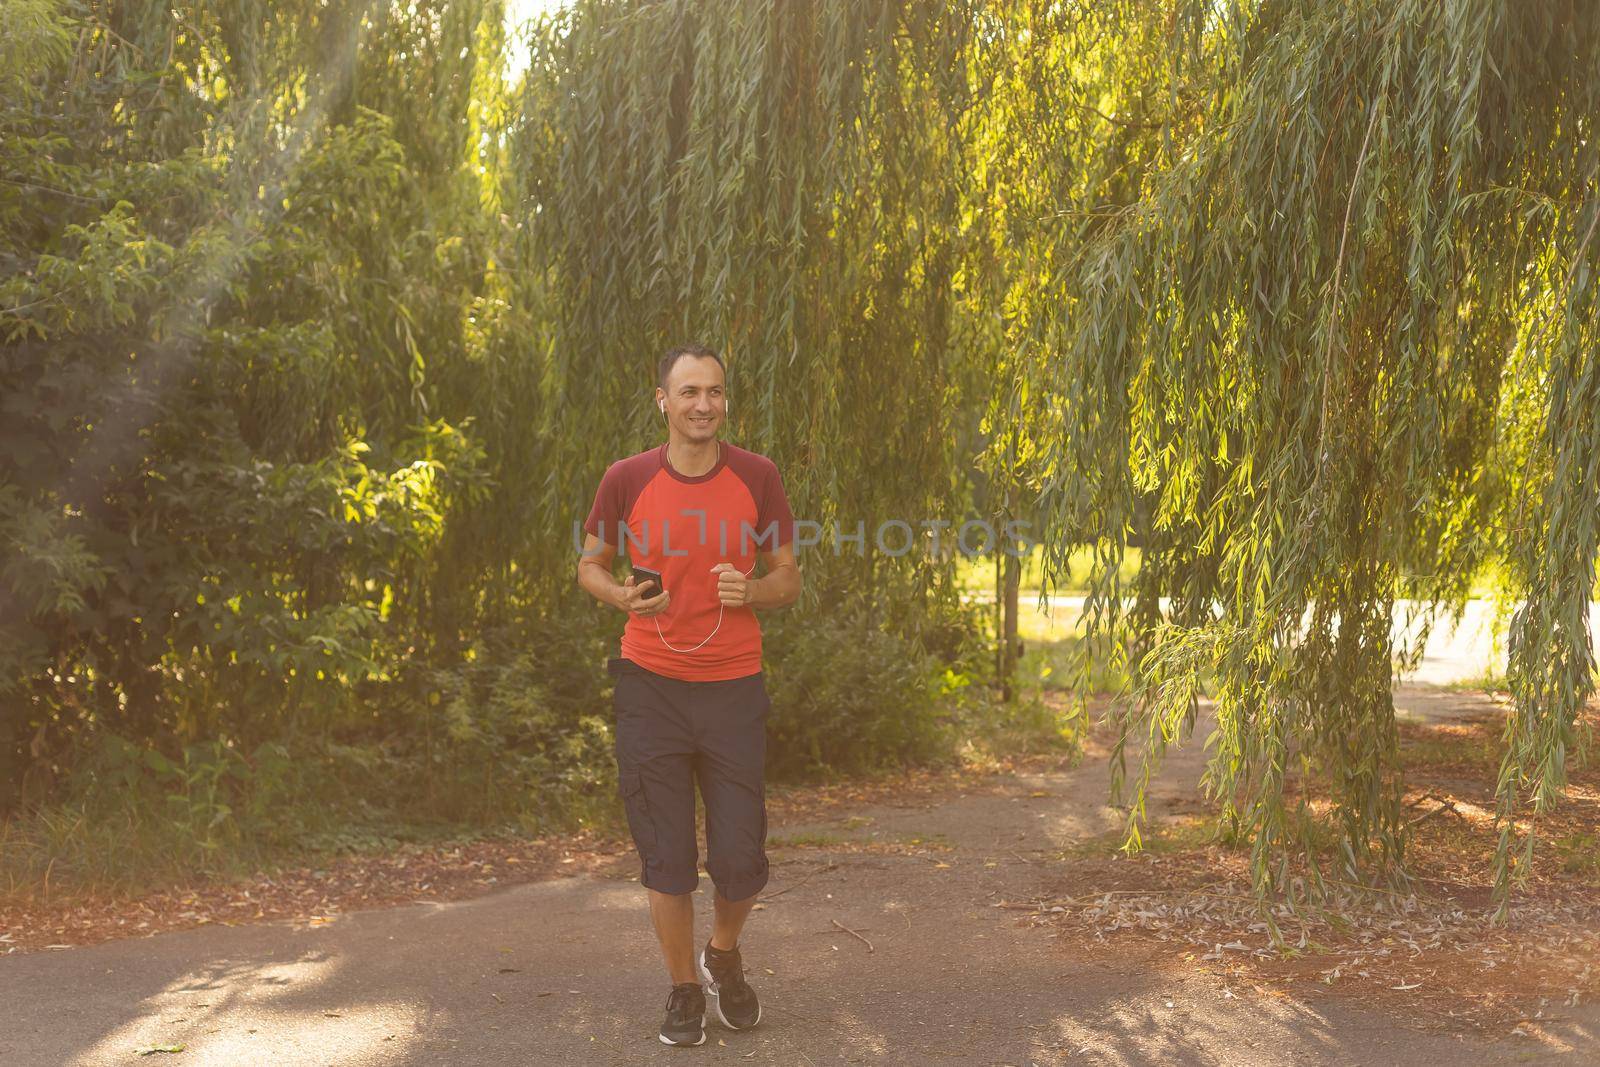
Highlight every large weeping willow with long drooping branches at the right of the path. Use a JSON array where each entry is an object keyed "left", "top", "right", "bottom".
[{"left": 1014, "top": 0, "right": 1600, "bottom": 893}]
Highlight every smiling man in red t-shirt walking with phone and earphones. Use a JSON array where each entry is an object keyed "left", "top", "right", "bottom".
[{"left": 578, "top": 344, "right": 800, "bottom": 1045}]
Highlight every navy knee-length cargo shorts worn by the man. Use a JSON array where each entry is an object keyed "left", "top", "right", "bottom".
[{"left": 606, "top": 657, "right": 773, "bottom": 901}]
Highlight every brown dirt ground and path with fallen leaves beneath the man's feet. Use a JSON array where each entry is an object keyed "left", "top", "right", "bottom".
[{"left": 0, "top": 686, "right": 1600, "bottom": 1067}]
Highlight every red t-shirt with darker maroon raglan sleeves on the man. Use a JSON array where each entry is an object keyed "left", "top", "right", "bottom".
[{"left": 584, "top": 442, "right": 794, "bottom": 681}]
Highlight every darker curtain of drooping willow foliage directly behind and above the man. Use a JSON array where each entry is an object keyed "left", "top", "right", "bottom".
[{"left": 506, "top": 0, "right": 987, "bottom": 627}]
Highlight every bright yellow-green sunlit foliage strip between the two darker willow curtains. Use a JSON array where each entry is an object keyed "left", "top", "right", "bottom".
[{"left": 957, "top": 0, "right": 1179, "bottom": 718}]
